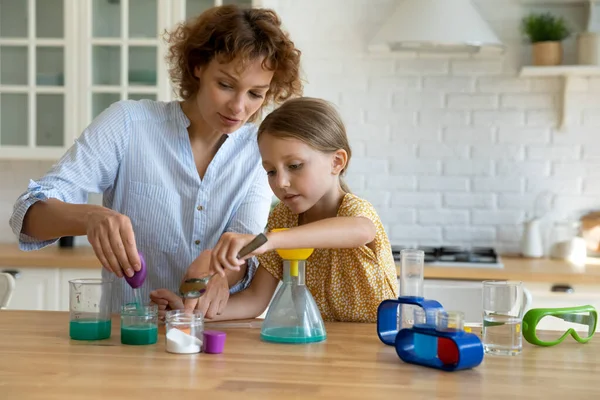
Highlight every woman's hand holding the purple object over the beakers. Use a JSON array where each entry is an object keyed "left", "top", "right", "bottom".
[{"left": 86, "top": 207, "right": 141, "bottom": 278}]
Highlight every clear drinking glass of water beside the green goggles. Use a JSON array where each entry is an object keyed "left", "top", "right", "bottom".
[{"left": 482, "top": 281, "right": 525, "bottom": 356}]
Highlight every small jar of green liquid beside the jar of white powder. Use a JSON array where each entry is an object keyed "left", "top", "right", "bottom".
[{"left": 121, "top": 303, "right": 158, "bottom": 345}]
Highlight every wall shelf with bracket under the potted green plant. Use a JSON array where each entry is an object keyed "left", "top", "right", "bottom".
[{"left": 519, "top": 65, "right": 600, "bottom": 130}]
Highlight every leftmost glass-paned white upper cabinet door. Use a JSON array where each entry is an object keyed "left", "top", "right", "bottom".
[{"left": 0, "top": 0, "right": 76, "bottom": 158}]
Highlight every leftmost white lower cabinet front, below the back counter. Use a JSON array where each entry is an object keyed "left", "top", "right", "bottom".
[{"left": 0, "top": 267, "right": 59, "bottom": 311}]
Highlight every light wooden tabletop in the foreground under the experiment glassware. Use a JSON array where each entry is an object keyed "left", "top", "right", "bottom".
[{"left": 0, "top": 311, "right": 600, "bottom": 400}]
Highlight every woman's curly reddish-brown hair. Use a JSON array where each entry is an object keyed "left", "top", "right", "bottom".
[{"left": 166, "top": 5, "right": 302, "bottom": 121}]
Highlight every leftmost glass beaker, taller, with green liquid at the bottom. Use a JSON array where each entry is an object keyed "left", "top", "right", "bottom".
[{"left": 69, "top": 279, "right": 112, "bottom": 340}]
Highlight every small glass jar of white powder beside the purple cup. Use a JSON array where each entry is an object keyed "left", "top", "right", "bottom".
[{"left": 165, "top": 310, "right": 204, "bottom": 354}]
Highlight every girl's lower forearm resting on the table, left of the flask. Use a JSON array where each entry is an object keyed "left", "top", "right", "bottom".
[{"left": 210, "top": 267, "right": 278, "bottom": 321}]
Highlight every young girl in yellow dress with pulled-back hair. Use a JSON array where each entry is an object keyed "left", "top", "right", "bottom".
[{"left": 151, "top": 97, "right": 398, "bottom": 322}]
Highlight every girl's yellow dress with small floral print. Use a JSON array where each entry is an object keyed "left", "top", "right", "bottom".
[{"left": 258, "top": 193, "right": 398, "bottom": 322}]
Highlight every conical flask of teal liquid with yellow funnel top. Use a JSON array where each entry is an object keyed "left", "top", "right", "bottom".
[{"left": 260, "top": 244, "right": 327, "bottom": 343}]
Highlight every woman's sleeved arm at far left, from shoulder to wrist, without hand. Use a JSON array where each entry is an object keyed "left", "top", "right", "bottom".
[{"left": 10, "top": 103, "right": 130, "bottom": 245}]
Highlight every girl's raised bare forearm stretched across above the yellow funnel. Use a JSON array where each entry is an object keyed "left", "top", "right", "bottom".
[{"left": 266, "top": 217, "right": 376, "bottom": 249}]
